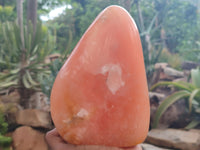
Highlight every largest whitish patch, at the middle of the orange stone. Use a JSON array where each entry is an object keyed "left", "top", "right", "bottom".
[{"left": 101, "top": 64, "right": 125, "bottom": 95}]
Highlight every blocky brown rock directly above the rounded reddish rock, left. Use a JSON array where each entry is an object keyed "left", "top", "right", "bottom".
[{"left": 16, "top": 109, "right": 52, "bottom": 129}]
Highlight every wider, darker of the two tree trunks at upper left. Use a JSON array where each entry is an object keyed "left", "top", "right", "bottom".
[{"left": 27, "top": 0, "right": 37, "bottom": 36}]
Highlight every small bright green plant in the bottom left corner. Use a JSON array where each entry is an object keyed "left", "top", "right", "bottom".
[{"left": 0, "top": 112, "right": 12, "bottom": 150}]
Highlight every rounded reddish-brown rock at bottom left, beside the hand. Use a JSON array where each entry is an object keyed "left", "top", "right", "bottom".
[{"left": 12, "top": 126, "right": 48, "bottom": 150}]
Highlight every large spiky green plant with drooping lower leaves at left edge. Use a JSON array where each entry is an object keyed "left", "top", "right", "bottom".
[{"left": 0, "top": 22, "right": 54, "bottom": 102}]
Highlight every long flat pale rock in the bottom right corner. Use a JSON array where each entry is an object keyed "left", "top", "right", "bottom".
[{"left": 146, "top": 129, "right": 200, "bottom": 150}]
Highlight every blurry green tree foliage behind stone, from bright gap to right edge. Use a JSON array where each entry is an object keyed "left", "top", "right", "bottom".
[{"left": 44, "top": 0, "right": 200, "bottom": 82}]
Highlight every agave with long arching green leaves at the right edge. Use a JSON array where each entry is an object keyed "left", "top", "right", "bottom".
[{"left": 151, "top": 68, "right": 200, "bottom": 129}]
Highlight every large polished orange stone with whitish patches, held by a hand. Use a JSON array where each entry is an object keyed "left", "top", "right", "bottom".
[{"left": 51, "top": 6, "right": 150, "bottom": 147}]
